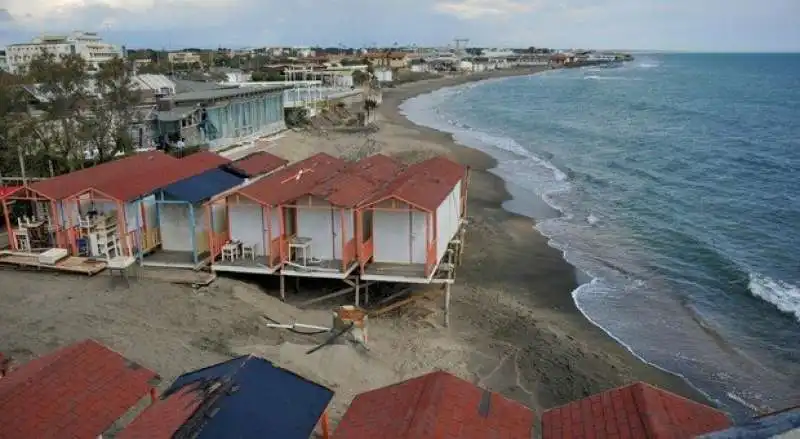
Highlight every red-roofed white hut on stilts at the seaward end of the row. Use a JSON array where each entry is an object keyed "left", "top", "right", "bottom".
[{"left": 357, "top": 157, "right": 468, "bottom": 283}]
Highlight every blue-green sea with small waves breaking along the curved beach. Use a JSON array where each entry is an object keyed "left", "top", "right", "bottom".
[{"left": 401, "top": 54, "right": 800, "bottom": 419}]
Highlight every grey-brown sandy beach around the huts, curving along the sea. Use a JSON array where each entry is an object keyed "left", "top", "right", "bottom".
[{"left": 0, "top": 67, "right": 702, "bottom": 434}]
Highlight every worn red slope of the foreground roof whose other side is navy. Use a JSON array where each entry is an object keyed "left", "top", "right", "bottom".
[{"left": 117, "top": 385, "right": 203, "bottom": 439}]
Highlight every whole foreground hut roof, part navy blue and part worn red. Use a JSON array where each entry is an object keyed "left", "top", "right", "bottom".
[{"left": 117, "top": 356, "right": 333, "bottom": 439}]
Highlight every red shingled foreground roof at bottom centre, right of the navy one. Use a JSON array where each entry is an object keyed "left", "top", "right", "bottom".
[{"left": 333, "top": 372, "right": 534, "bottom": 439}]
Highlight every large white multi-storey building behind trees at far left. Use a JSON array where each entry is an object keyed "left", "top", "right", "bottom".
[{"left": 6, "top": 32, "right": 123, "bottom": 73}]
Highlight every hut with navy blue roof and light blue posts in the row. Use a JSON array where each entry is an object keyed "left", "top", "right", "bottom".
[{"left": 142, "top": 151, "right": 245, "bottom": 269}]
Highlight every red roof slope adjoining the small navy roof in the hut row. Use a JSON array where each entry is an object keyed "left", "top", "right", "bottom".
[{"left": 91, "top": 151, "right": 231, "bottom": 201}]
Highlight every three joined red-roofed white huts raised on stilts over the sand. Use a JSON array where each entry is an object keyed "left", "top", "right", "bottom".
[{"left": 207, "top": 153, "right": 468, "bottom": 320}]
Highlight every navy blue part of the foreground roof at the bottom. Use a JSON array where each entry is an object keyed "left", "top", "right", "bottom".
[{"left": 165, "top": 356, "right": 333, "bottom": 439}]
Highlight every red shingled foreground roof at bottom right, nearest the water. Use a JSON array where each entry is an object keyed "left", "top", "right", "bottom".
[{"left": 542, "top": 382, "right": 731, "bottom": 439}]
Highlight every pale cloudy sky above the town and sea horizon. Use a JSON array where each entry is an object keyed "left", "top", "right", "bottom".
[{"left": 0, "top": 0, "right": 800, "bottom": 52}]
